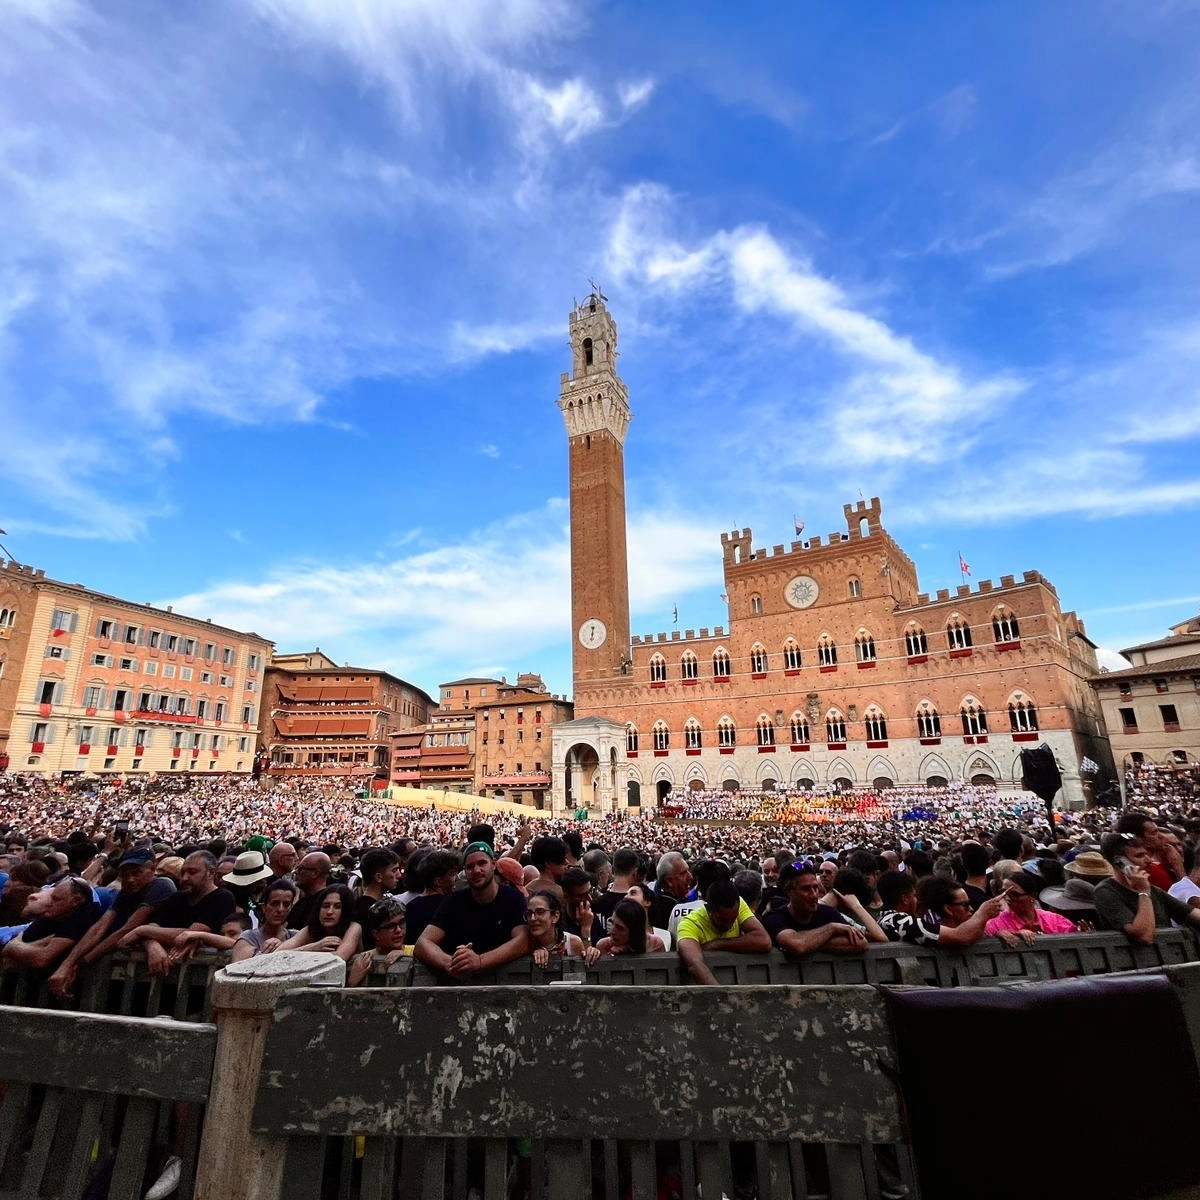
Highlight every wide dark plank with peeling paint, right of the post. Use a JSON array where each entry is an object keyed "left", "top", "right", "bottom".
[{"left": 253, "top": 984, "right": 902, "bottom": 1142}]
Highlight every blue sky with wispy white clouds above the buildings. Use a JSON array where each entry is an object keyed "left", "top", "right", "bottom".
[{"left": 0, "top": 0, "right": 1200, "bottom": 692}]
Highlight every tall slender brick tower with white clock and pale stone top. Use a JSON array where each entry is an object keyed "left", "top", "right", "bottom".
[{"left": 558, "top": 288, "right": 632, "bottom": 698}]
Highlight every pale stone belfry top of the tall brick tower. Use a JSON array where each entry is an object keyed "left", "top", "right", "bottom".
[{"left": 558, "top": 283, "right": 632, "bottom": 443}]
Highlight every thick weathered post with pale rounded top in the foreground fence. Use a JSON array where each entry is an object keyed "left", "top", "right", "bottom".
[{"left": 194, "top": 950, "right": 346, "bottom": 1200}]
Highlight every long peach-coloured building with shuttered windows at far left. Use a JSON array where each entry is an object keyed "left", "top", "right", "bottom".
[{"left": 0, "top": 560, "right": 272, "bottom": 776}]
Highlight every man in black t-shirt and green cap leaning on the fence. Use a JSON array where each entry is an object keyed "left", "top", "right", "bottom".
[{"left": 413, "top": 841, "right": 529, "bottom": 979}]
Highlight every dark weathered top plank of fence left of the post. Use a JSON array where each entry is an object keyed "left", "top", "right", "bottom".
[{"left": 0, "top": 1008, "right": 216, "bottom": 1100}]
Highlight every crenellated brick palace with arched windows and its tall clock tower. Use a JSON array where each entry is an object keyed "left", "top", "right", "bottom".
[{"left": 552, "top": 294, "right": 1111, "bottom": 811}]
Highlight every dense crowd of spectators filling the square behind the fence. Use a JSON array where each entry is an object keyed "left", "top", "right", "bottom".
[{"left": 0, "top": 776, "right": 1200, "bottom": 996}]
